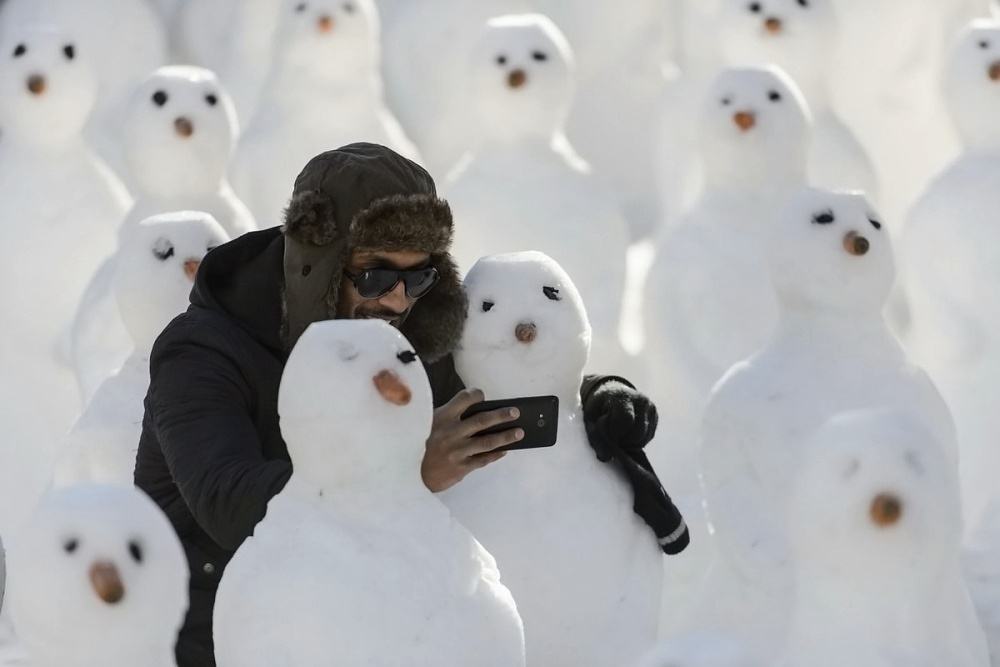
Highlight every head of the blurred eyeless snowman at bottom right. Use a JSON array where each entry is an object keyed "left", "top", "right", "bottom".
[{"left": 790, "top": 410, "right": 962, "bottom": 591}]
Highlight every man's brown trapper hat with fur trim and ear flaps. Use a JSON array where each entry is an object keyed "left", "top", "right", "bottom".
[{"left": 282, "top": 143, "right": 467, "bottom": 362}]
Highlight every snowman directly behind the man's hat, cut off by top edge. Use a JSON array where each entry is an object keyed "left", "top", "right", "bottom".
[{"left": 232, "top": 0, "right": 417, "bottom": 226}]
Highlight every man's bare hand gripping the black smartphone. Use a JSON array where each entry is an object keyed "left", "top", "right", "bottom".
[{"left": 420, "top": 389, "right": 524, "bottom": 493}]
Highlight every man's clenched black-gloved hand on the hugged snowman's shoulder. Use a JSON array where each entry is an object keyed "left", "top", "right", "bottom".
[{"left": 583, "top": 380, "right": 658, "bottom": 461}]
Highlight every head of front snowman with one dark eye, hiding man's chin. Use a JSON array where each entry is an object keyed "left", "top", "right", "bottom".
[{"left": 278, "top": 320, "right": 433, "bottom": 486}]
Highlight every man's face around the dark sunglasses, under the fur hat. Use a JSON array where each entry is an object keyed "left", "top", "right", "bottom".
[{"left": 337, "top": 250, "right": 431, "bottom": 329}]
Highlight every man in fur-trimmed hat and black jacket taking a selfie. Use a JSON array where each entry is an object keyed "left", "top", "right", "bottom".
[{"left": 135, "top": 144, "right": 680, "bottom": 667}]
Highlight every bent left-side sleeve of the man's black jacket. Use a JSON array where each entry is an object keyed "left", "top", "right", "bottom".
[{"left": 146, "top": 328, "right": 292, "bottom": 551}]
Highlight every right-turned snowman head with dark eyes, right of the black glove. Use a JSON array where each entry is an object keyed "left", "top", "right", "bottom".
[{"left": 767, "top": 188, "right": 896, "bottom": 315}]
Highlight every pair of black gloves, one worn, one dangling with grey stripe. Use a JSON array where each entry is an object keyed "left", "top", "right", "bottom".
[{"left": 583, "top": 378, "right": 691, "bottom": 554}]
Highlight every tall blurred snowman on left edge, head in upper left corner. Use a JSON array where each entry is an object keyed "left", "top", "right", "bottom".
[{"left": 0, "top": 27, "right": 128, "bottom": 544}]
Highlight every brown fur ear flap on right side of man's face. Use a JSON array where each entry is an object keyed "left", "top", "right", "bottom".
[{"left": 401, "top": 254, "right": 469, "bottom": 363}]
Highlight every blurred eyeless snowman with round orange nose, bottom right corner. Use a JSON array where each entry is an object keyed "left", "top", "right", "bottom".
[{"left": 778, "top": 409, "right": 989, "bottom": 667}]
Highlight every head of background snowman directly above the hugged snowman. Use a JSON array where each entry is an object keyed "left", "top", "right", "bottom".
[{"left": 469, "top": 14, "right": 574, "bottom": 141}]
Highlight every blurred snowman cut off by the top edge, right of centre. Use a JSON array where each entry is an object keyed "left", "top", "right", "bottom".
[{"left": 718, "top": 0, "right": 878, "bottom": 209}]
